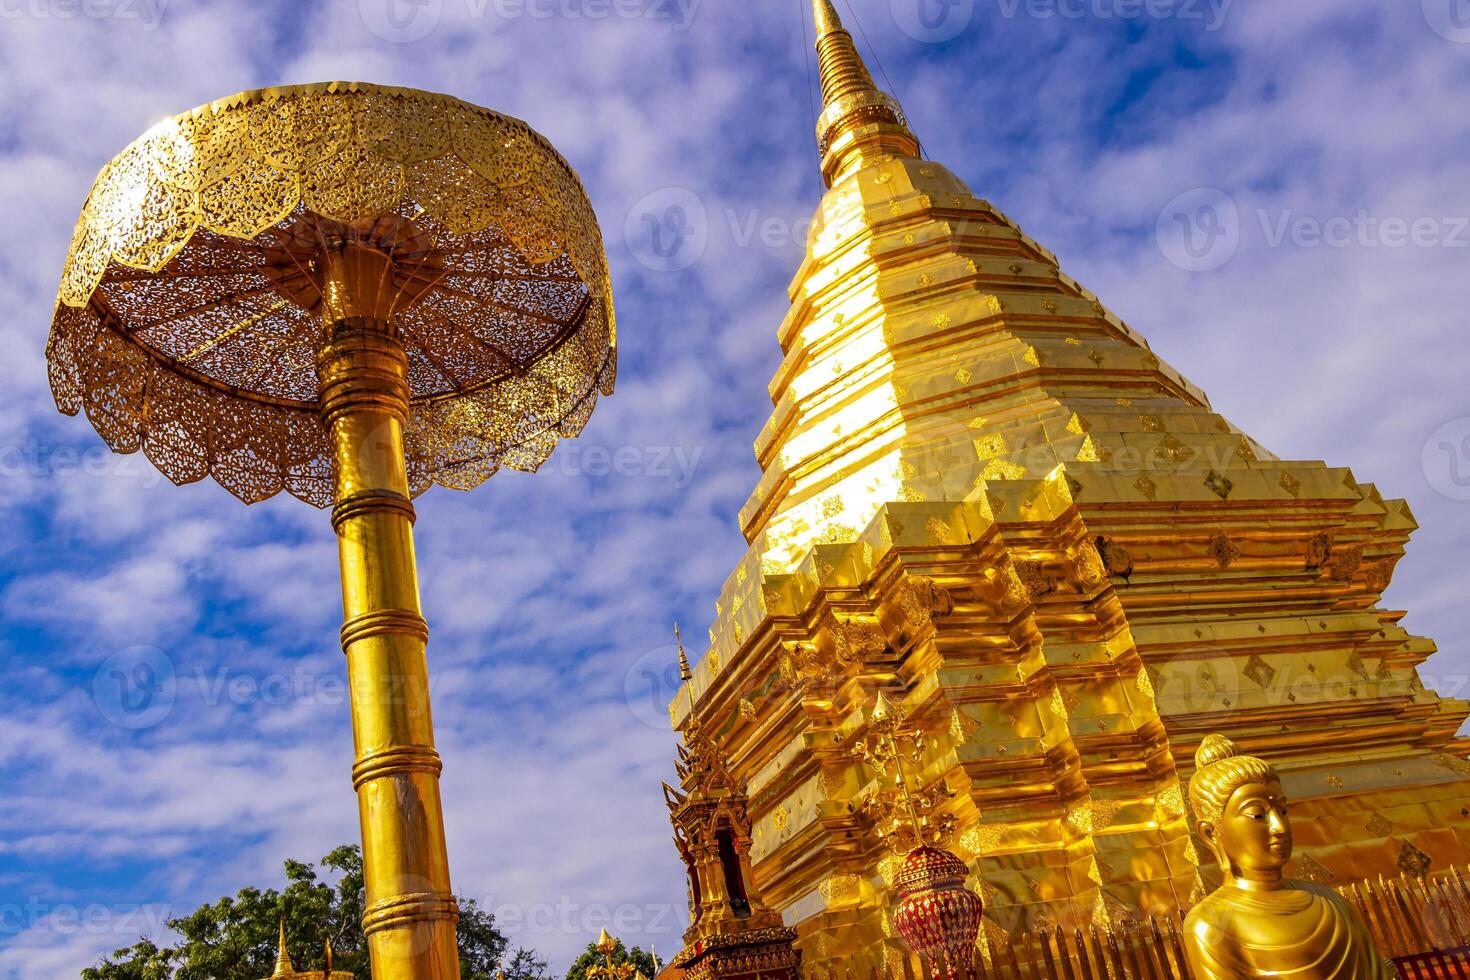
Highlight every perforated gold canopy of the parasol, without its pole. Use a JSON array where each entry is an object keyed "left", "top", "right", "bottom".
[{"left": 47, "top": 82, "right": 616, "bottom": 507}]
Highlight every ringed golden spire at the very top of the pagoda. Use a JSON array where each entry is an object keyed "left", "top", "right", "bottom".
[{"left": 811, "top": 0, "right": 919, "bottom": 187}]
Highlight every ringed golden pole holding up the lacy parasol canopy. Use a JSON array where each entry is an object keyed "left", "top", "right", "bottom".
[{"left": 318, "top": 244, "right": 459, "bottom": 980}]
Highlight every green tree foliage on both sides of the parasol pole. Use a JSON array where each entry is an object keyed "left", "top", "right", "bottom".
[{"left": 82, "top": 845, "right": 548, "bottom": 980}]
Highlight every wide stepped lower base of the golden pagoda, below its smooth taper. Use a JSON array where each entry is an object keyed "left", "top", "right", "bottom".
[{"left": 685, "top": 476, "right": 1470, "bottom": 977}]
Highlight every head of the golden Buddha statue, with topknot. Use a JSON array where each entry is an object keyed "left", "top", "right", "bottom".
[{"left": 1189, "top": 735, "right": 1292, "bottom": 882}]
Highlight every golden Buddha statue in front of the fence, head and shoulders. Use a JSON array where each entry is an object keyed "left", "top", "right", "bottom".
[{"left": 1185, "top": 735, "right": 1398, "bottom": 980}]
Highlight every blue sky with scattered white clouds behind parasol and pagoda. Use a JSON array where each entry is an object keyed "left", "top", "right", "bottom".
[{"left": 0, "top": 0, "right": 1470, "bottom": 980}]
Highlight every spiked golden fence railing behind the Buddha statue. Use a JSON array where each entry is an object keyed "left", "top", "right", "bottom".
[{"left": 870, "top": 868, "right": 1470, "bottom": 980}]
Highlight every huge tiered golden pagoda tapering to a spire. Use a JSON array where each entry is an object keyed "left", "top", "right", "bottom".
[{"left": 670, "top": 0, "right": 1470, "bottom": 977}]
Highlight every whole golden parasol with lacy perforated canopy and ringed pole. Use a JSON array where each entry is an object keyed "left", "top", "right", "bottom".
[{"left": 47, "top": 82, "right": 616, "bottom": 980}]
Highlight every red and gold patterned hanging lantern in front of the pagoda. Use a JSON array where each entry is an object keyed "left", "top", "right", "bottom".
[{"left": 894, "top": 845, "right": 985, "bottom": 977}]
